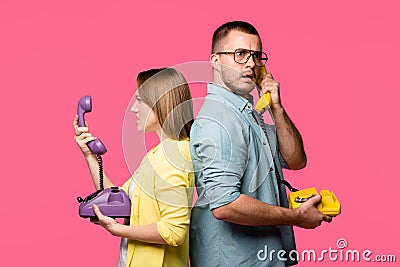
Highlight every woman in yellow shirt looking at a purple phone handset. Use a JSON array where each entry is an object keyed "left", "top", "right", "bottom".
[{"left": 74, "top": 68, "right": 194, "bottom": 266}]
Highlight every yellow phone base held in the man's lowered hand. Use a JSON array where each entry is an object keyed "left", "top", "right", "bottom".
[{"left": 289, "top": 187, "right": 341, "bottom": 216}]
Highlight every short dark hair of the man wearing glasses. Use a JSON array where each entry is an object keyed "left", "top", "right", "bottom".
[{"left": 211, "top": 21, "right": 260, "bottom": 54}]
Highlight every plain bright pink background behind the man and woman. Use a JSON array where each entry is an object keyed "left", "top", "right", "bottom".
[{"left": 0, "top": 0, "right": 400, "bottom": 266}]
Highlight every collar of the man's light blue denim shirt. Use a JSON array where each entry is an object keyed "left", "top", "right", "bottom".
[{"left": 207, "top": 83, "right": 254, "bottom": 111}]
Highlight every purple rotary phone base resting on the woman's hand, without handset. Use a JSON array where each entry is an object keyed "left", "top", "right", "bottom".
[{"left": 79, "top": 187, "right": 131, "bottom": 218}]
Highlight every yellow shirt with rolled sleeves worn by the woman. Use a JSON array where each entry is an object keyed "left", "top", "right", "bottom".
[{"left": 122, "top": 139, "right": 194, "bottom": 267}]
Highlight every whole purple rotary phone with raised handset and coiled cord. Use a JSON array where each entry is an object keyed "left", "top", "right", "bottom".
[{"left": 78, "top": 96, "right": 131, "bottom": 218}]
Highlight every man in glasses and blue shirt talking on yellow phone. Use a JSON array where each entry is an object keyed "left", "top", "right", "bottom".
[{"left": 190, "top": 21, "right": 331, "bottom": 267}]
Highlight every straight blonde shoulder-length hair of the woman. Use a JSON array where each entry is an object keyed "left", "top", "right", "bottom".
[{"left": 137, "top": 68, "right": 193, "bottom": 140}]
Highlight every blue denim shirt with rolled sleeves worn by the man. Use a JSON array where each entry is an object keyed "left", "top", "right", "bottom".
[{"left": 190, "top": 84, "right": 295, "bottom": 267}]
